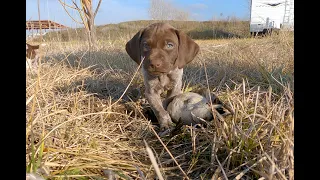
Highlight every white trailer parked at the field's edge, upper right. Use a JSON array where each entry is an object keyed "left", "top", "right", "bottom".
[{"left": 250, "top": 0, "right": 294, "bottom": 34}]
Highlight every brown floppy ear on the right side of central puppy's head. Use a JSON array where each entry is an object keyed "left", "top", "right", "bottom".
[{"left": 175, "top": 30, "right": 199, "bottom": 69}]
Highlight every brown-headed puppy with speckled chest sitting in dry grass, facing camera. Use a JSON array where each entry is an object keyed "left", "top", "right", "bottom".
[{"left": 126, "top": 23, "right": 199, "bottom": 131}]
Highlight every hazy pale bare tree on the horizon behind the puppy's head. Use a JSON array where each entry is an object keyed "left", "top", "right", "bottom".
[{"left": 149, "top": 0, "right": 190, "bottom": 21}]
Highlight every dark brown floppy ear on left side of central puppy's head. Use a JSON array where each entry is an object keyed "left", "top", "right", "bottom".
[{"left": 126, "top": 29, "right": 144, "bottom": 64}]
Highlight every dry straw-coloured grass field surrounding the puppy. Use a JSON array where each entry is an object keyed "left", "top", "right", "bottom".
[{"left": 26, "top": 20, "right": 294, "bottom": 180}]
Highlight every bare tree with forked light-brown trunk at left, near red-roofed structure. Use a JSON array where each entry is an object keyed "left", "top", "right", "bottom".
[{"left": 59, "top": 0, "right": 102, "bottom": 47}]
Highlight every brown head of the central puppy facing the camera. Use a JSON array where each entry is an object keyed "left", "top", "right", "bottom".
[{"left": 126, "top": 23, "right": 199, "bottom": 75}]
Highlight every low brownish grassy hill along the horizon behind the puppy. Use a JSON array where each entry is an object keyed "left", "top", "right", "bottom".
[{"left": 38, "top": 18, "right": 249, "bottom": 42}]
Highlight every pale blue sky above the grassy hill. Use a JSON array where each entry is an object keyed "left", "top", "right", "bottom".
[{"left": 26, "top": 0, "right": 250, "bottom": 27}]
